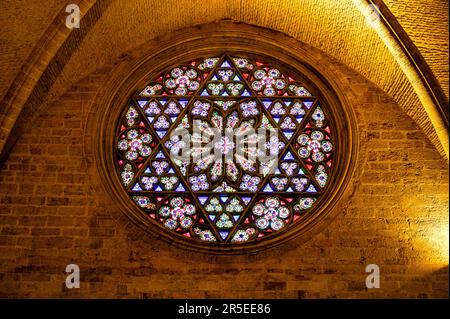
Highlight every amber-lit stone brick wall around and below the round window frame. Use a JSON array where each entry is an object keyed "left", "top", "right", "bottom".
[{"left": 0, "top": 43, "right": 449, "bottom": 298}]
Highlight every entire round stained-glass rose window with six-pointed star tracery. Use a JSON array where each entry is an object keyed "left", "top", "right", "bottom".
[{"left": 115, "top": 54, "right": 336, "bottom": 246}]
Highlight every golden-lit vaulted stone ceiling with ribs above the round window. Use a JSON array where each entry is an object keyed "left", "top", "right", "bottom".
[{"left": 0, "top": 0, "right": 449, "bottom": 158}]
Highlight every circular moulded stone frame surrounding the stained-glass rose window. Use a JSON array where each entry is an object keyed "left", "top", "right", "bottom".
[{"left": 85, "top": 24, "right": 359, "bottom": 254}]
